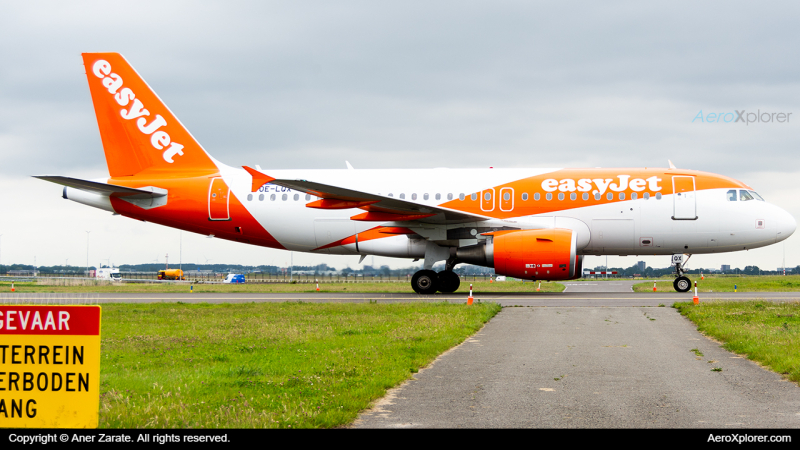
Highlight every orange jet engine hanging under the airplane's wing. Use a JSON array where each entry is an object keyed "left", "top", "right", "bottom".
[{"left": 456, "top": 228, "right": 583, "bottom": 280}]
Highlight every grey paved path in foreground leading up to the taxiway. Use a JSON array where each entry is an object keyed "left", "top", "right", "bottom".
[{"left": 354, "top": 307, "right": 800, "bottom": 428}]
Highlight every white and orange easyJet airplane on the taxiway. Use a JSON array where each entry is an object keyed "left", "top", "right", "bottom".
[{"left": 38, "top": 53, "right": 796, "bottom": 294}]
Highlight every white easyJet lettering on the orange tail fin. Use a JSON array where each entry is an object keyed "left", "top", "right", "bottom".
[{"left": 92, "top": 59, "right": 183, "bottom": 164}]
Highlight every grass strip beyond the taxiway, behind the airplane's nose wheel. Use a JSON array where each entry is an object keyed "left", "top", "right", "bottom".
[{"left": 633, "top": 275, "right": 800, "bottom": 292}]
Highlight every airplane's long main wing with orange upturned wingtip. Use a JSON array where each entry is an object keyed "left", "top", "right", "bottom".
[{"left": 245, "top": 167, "right": 484, "bottom": 223}]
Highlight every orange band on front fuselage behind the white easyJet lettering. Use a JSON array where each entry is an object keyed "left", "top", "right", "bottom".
[{"left": 439, "top": 168, "right": 750, "bottom": 219}]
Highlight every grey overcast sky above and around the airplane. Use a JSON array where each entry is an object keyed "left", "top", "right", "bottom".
[{"left": 0, "top": 1, "right": 800, "bottom": 270}]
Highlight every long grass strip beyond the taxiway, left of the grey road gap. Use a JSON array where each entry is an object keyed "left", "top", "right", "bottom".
[{"left": 0, "top": 280, "right": 564, "bottom": 294}]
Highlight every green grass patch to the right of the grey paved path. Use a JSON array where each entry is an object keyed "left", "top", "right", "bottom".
[{"left": 675, "top": 301, "right": 800, "bottom": 383}]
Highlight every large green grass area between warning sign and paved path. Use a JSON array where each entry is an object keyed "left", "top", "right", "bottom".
[{"left": 95, "top": 303, "right": 500, "bottom": 428}]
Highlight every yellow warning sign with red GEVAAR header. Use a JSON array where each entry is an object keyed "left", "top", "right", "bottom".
[{"left": 0, "top": 305, "right": 101, "bottom": 428}]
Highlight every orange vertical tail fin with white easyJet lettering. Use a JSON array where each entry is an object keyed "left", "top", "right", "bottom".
[{"left": 82, "top": 53, "right": 217, "bottom": 177}]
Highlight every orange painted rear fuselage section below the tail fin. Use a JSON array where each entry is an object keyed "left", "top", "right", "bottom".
[{"left": 108, "top": 171, "right": 285, "bottom": 249}]
